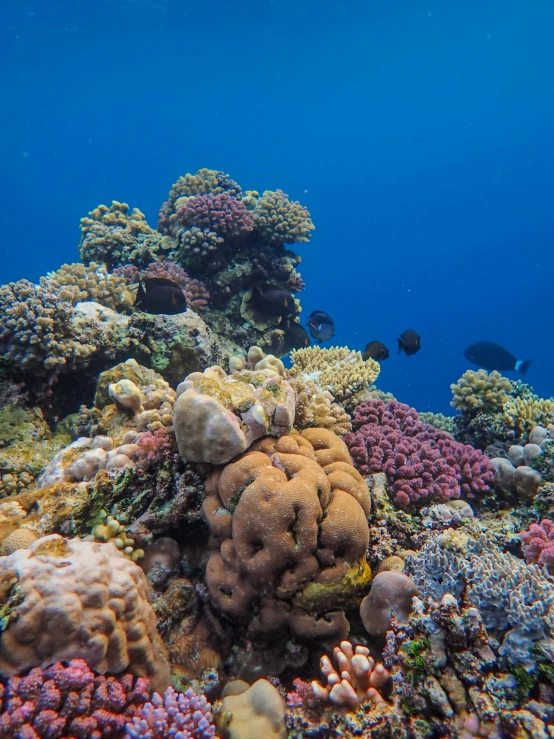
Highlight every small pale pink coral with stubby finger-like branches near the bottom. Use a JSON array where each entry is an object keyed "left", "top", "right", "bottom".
[{"left": 312, "top": 641, "right": 390, "bottom": 711}]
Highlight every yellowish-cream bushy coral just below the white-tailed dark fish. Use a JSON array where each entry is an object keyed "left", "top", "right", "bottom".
[{"left": 450, "top": 369, "right": 514, "bottom": 413}]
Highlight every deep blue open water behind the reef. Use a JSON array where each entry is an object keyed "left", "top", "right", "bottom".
[{"left": 0, "top": 0, "right": 554, "bottom": 412}]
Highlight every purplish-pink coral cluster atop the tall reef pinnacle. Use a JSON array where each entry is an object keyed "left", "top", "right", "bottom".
[{"left": 177, "top": 193, "right": 254, "bottom": 238}]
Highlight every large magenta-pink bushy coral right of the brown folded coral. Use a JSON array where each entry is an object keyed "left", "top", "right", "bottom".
[{"left": 344, "top": 400, "right": 494, "bottom": 508}]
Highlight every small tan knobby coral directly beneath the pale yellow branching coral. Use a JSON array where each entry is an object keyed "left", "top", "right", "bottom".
[{"left": 289, "top": 378, "right": 352, "bottom": 436}]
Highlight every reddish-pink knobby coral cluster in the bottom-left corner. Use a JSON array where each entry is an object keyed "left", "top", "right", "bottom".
[{"left": 0, "top": 659, "right": 150, "bottom": 739}]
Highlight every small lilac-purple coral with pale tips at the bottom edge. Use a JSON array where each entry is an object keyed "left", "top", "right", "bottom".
[{"left": 125, "top": 687, "right": 215, "bottom": 739}]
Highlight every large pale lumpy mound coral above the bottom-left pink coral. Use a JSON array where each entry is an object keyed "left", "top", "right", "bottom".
[{"left": 0, "top": 534, "right": 169, "bottom": 691}]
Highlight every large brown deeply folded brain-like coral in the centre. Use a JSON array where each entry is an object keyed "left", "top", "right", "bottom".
[{"left": 202, "top": 428, "right": 371, "bottom": 639}]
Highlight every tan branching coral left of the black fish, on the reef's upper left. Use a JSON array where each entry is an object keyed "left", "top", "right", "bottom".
[{"left": 46, "top": 262, "right": 134, "bottom": 311}]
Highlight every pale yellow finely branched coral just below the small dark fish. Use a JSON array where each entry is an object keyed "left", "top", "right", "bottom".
[{"left": 289, "top": 346, "right": 380, "bottom": 410}]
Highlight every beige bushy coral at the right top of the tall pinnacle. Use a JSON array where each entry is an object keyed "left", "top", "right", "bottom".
[{"left": 253, "top": 190, "right": 315, "bottom": 244}]
